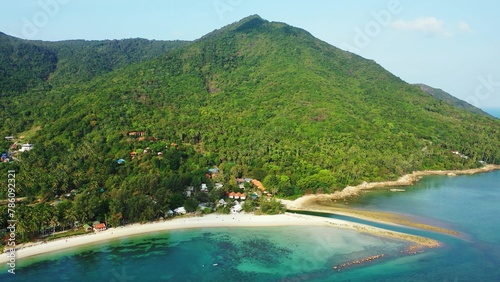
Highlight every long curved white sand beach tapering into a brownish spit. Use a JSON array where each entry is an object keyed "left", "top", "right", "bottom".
[{"left": 0, "top": 213, "right": 441, "bottom": 263}]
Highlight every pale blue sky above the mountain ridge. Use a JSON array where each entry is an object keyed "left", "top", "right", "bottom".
[{"left": 0, "top": 0, "right": 500, "bottom": 109}]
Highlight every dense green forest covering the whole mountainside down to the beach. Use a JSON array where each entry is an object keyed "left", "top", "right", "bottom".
[{"left": 0, "top": 16, "right": 500, "bottom": 240}]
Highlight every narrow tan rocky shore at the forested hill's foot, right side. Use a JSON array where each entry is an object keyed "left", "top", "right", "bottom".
[{"left": 281, "top": 165, "right": 500, "bottom": 209}]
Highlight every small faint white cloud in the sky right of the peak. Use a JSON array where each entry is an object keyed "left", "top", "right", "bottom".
[{"left": 391, "top": 17, "right": 453, "bottom": 36}]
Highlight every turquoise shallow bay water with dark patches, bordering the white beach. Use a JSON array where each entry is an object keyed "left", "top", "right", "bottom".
[{"left": 0, "top": 227, "right": 407, "bottom": 282}]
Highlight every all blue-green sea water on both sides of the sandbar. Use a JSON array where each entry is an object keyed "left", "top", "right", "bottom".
[{"left": 0, "top": 171, "right": 500, "bottom": 282}]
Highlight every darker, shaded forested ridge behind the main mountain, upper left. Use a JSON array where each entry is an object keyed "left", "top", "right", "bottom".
[{"left": 0, "top": 32, "right": 188, "bottom": 95}]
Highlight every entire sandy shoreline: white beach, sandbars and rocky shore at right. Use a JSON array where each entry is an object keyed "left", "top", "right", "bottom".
[{"left": 0, "top": 165, "right": 500, "bottom": 263}]
